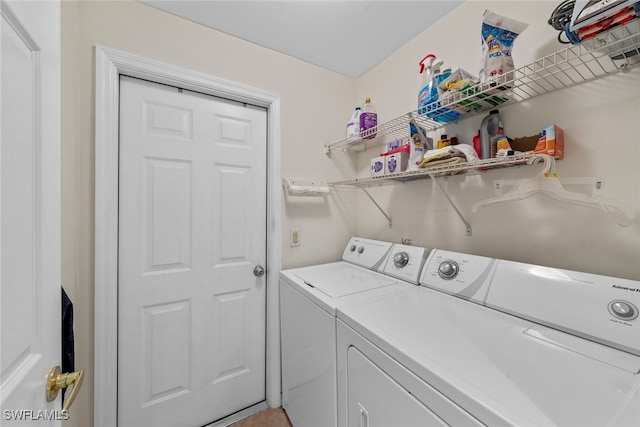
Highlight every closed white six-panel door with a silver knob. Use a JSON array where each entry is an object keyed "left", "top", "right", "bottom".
[{"left": 118, "top": 76, "right": 267, "bottom": 427}]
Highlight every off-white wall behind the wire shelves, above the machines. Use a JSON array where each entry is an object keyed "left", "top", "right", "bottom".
[{"left": 356, "top": 1, "right": 640, "bottom": 280}]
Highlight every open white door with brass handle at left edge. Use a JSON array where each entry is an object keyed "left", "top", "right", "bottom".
[{"left": 0, "top": 1, "right": 66, "bottom": 426}]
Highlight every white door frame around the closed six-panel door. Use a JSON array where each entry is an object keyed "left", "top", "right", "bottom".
[{"left": 94, "top": 45, "right": 281, "bottom": 427}]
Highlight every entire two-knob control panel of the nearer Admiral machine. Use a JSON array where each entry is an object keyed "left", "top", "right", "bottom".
[{"left": 420, "top": 249, "right": 640, "bottom": 356}]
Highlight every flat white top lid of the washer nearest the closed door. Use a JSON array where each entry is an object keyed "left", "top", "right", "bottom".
[{"left": 295, "top": 263, "right": 398, "bottom": 298}]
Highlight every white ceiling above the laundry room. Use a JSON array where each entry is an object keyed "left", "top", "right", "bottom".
[{"left": 140, "top": 0, "right": 462, "bottom": 77}]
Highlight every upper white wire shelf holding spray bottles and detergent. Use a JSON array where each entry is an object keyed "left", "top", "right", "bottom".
[{"left": 325, "top": 19, "right": 640, "bottom": 155}]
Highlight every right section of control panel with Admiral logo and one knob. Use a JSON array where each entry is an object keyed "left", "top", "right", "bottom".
[{"left": 487, "top": 260, "right": 640, "bottom": 356}]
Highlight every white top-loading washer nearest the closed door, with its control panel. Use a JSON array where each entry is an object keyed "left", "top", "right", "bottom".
[{"left": 280, "top": 237, "right": 428, "bottom": 427}]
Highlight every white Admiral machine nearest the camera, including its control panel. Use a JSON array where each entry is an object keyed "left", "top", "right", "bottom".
[{"left": 337, "top": 250, "right": 640, "bottom": 427}]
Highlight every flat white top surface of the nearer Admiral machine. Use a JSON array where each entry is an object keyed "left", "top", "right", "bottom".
[{"left": 338, "top": 287, "right": 640, "bottom": 426}]
